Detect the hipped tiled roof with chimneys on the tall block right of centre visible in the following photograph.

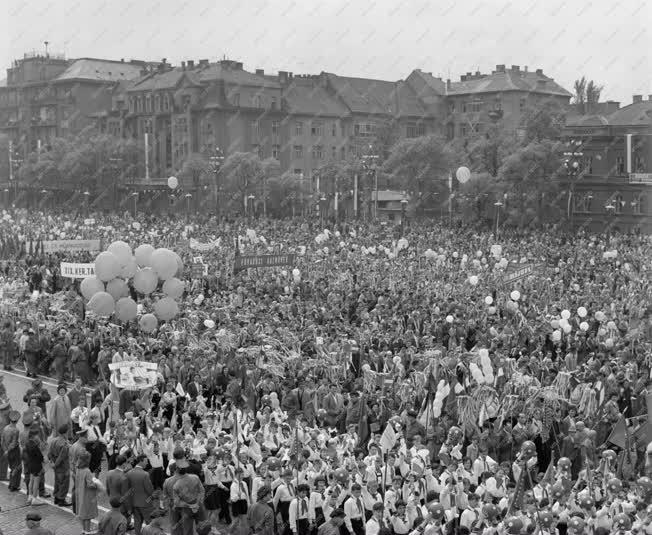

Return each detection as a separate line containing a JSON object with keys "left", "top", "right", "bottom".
{"left": 447, "top": 70, "right": 572, "bottom": 97}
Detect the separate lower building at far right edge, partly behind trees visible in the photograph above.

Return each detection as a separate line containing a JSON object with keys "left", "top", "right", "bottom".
{"left": 564, "top": 95, "right": 652, "bottom": 233}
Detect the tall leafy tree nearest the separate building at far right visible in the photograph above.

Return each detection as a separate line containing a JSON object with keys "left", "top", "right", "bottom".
{"left": 498, "top": 139, "right": 564, "bottom": 226}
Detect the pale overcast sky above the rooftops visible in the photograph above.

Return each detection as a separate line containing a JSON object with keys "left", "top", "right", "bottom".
{"left": 0, "top": 0, "right": 652, "bottom": 104}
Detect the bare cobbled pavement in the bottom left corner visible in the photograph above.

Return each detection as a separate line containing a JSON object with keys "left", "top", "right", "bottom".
{"left": 0, "top": 481, "right": 82, "bottom": 535}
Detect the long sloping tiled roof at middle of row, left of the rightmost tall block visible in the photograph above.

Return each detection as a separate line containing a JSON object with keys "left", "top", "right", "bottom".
{"left": 323, "top": 73, "right": 425, "bottom": 116}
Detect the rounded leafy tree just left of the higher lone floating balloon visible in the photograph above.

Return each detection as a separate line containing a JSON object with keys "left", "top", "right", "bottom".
{"left": 383, "top": 136, "right": 454, "bottom": 195}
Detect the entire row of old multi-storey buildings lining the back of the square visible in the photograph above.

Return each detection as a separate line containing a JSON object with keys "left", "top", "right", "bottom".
{"left": 0, "top": 53, "right": 652, "bottom": 232}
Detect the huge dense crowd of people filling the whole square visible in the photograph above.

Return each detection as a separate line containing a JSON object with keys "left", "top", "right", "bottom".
{"left": 0, "top": 206, "right": 652, "bottom": 535}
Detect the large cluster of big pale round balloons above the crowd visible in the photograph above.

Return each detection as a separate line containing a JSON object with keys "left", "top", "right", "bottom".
{"left": 81, "top": 241, "right": 185, "bottom": 332}
